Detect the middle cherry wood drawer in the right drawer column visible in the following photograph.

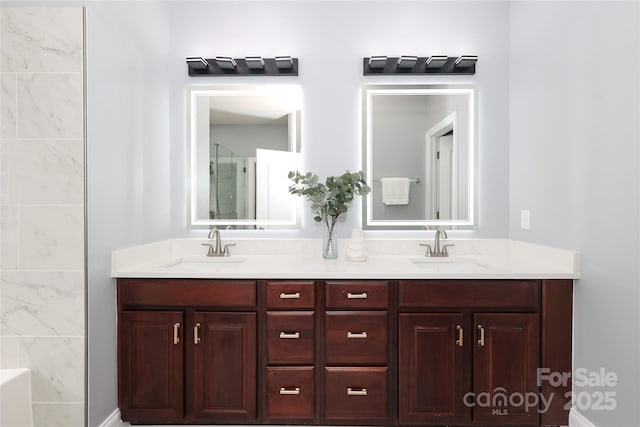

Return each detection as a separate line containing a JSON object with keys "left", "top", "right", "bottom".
{"left": 325, "top": 311, "right": 389, "bottom": 365}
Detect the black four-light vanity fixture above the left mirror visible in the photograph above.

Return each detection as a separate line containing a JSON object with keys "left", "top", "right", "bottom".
{"left": 186, "top": 56, "right": 298, "bottom": 76}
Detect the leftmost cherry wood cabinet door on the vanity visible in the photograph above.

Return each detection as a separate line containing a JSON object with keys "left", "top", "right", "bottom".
{"left": 118, "top": 311, "right": 184, "bottom": 423}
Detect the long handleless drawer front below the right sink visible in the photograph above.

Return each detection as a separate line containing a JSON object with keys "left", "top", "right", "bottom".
{"left": 399, "top": 280, "right": 540, "bottom": 311}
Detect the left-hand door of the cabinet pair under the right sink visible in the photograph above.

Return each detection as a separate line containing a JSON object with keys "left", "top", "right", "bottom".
{"left": 398, "top": 313, "right": 469, "bottom": 425}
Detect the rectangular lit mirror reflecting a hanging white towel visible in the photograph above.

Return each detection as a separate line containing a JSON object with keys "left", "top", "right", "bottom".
{"left": 363, "top": 85, "right": 476, "bottom": 229}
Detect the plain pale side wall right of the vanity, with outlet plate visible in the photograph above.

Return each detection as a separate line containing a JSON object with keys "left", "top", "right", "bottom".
{"left": 510, "top": 2, "right": 640, "bottom": 427}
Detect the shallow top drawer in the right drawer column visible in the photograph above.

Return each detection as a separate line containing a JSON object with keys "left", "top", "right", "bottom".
{"left": 325, "top": 281, "right": 389, "bottom": 309}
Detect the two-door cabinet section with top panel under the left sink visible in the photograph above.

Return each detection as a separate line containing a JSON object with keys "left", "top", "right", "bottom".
{"left": 118, "top": 279, "right": 257, "bottom": 424}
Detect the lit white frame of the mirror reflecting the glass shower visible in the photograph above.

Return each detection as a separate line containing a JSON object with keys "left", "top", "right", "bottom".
{"left": 186, "top": 84, "right": 302, "bottom": 230}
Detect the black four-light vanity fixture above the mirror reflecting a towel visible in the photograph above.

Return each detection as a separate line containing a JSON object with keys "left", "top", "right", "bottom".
{"left": 363, "top": 55, "right": 478, "bottom": 76}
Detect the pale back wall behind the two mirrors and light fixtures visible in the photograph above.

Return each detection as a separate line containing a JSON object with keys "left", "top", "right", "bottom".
{"left": 169, "top": 1, "right": 509, "bottom": 237}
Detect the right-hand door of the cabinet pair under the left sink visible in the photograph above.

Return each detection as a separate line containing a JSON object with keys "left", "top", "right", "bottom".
{"left": 193, "top": 312, "right": 257, "bottom": 423}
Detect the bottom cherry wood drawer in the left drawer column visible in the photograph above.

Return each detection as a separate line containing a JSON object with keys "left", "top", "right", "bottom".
{"left": 267, "top": 366, "right": 315, "bottom": 419}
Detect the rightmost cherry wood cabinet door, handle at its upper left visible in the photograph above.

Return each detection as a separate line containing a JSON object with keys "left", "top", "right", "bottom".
{"left": 473, "top": 314, "right": 540, "bottom": 425}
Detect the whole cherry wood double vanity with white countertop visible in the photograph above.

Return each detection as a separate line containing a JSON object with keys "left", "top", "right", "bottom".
{"left": 113, "top": 242, "right": 578, "bottom": 426}
